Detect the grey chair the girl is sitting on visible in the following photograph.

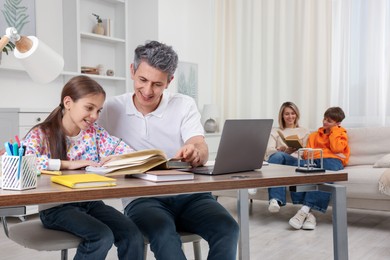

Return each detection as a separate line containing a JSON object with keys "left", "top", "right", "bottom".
{"left": 0, "top": 207, "right": 82, "bottom": 260}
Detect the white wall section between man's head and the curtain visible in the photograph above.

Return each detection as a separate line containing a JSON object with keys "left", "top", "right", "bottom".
{"left": 158, "top": 0, "right": 214, "bottom": 109}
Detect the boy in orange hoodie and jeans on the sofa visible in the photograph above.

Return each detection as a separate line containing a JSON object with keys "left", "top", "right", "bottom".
{"left": 289, "top": 107, "right": 350, "bottom": 230}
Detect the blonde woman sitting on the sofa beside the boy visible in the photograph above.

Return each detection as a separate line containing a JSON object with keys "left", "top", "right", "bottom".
{"left": 265, "top": 102, "right": 310, "bottom": 213}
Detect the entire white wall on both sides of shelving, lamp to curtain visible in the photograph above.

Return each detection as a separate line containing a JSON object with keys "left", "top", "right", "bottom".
{"left": 0, "top": 0, "right": 214, "bottom": 110}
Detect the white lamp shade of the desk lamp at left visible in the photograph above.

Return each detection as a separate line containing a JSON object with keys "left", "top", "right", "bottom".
{"left": 14, "top": 36, "right": 64, "bottom": 83}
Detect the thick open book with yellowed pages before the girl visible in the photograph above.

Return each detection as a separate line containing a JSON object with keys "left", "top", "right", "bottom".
{"left": 85, "top": 149, "right": 191, "bottom": 176}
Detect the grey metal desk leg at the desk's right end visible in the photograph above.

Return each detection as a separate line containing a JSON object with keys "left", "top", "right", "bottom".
{"left": 318, "top": 183, "right": 348, "bottom": 260}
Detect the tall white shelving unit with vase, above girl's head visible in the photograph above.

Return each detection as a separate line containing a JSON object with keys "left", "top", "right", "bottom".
{"left": 62, "top": 0, "right": 129, "bottom": 91}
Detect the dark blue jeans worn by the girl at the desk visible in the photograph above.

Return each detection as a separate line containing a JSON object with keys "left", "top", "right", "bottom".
{"left": 40, "top": 201, "right": 144, "bottom": 260}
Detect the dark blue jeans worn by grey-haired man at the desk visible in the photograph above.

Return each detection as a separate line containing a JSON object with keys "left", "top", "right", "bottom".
{"left": 125, "top": 193, "right": 239, "bottom": 260}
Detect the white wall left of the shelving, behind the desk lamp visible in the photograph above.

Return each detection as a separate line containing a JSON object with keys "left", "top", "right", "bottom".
{"left": 0, "top": 0, "right": 63, "bottom": 110}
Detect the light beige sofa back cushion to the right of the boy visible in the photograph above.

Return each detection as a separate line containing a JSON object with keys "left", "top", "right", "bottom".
{"left": 347, "top": 127, "right": 390, "bottom": 166}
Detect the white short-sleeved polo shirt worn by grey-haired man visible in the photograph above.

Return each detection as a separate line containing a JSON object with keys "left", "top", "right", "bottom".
{"left": 99, "top": 91, "right": 204, "bottom": 158}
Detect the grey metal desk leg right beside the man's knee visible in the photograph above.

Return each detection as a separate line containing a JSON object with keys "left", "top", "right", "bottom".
{"left": 237, "top": 189, "right": 250, "bottom": 260}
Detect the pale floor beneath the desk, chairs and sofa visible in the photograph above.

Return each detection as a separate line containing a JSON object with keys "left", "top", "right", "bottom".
{"left": 0, "top": 197, "right": 390, "bottom": 260}
